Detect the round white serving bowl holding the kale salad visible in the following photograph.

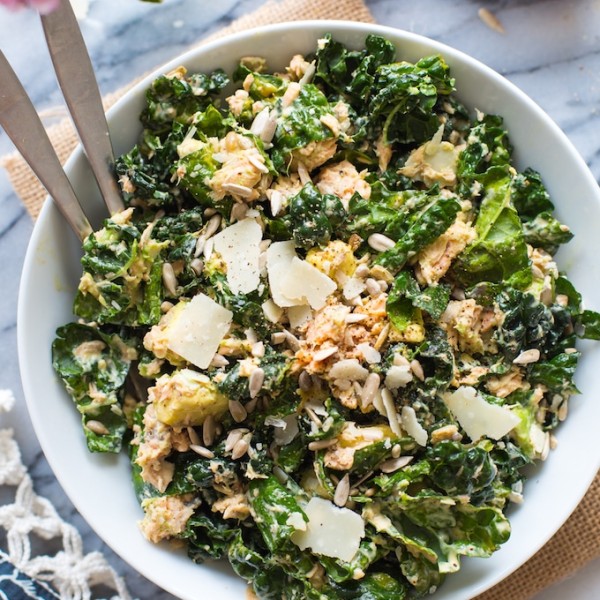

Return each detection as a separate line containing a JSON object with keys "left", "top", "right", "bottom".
{"left": 18, "top": 21, "right": 600, "bottom": 600}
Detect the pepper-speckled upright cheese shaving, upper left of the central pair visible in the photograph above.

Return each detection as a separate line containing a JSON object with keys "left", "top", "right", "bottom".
{"left": 213, "top": 219, "right": 262, "bottom": 294}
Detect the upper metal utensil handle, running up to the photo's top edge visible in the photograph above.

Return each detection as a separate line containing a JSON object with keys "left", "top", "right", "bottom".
{"left": 41, "top": 0, "right": 124, "bottom": 215}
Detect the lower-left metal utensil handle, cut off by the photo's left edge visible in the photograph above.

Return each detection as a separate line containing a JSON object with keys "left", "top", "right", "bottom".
{"left": 0, "top": 51, "right": 92, "bottom": 240}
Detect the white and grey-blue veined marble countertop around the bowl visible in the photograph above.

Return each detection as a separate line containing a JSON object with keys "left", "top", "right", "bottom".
{"left": 0, "top": 0, "right": 600, "bottom": 600}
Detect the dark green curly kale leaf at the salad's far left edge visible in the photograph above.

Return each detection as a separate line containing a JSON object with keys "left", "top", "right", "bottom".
{"left": 52, "top": 323, "right": 135, "bottom": 452}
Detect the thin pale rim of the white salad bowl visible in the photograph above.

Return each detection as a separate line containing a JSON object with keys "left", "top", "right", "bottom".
{"left": 17, "top": 19, "right": 600, "bottom": 597}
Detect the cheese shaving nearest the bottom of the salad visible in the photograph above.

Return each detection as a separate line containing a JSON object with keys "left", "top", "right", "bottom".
{"left": 291, "top": 497, "right": 365, "bottom": 562}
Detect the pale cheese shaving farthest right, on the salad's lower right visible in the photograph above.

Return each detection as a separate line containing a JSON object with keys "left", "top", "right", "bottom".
{"left": 444, "top": 386, "right": 519, "bottom": 441}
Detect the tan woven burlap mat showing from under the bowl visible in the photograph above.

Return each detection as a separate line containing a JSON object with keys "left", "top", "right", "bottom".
{"left": 1, "top": 0, "right": 600, "bottom": 600}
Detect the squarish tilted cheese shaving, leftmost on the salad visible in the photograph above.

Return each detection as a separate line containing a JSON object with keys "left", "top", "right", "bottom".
{"left": 167, "top": 294, "right": 233, "bottom": 369}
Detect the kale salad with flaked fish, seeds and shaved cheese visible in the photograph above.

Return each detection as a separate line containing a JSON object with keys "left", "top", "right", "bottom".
{"left": 52, "top": 35, "right": 600, "bottom": 600}
